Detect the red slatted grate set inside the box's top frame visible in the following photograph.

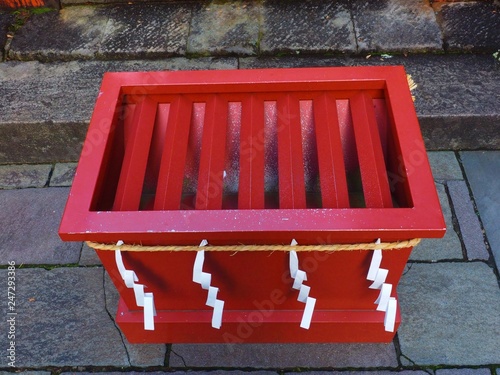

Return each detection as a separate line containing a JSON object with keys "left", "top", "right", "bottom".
{"left": 96, "top": 90, "right": 406, "bottom": 211}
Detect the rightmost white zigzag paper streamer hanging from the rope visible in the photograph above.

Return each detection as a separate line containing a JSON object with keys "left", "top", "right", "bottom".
{"left": 366, "top": 238, "right": 398, "bottom": 332}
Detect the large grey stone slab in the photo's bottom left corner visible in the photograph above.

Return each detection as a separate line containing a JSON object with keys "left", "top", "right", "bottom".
{"left": 0, "top": 268, "right": 130, "bottom": 368}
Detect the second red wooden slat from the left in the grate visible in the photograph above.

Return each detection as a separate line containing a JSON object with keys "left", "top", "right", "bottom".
{"left": 154, "top": 96, "right": 193, "bottom": 210}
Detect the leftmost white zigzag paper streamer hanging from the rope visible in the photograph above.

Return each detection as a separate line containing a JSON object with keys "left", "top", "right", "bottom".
{"left": 115, "top": 247, "right": 156, "bottom": 331}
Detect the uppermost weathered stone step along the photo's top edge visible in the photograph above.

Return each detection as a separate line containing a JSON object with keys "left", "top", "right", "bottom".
{"left": 0, "top": 0, "right": 500, "bottom": 61}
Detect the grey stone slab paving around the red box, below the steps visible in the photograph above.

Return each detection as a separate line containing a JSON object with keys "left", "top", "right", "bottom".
{"left": 0, "top": 151, "right": 500, "bottom": 375}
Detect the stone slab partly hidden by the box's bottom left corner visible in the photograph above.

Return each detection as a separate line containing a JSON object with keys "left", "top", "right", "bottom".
{"left": 104, "top": 272, "right": 167, "bottom": 367}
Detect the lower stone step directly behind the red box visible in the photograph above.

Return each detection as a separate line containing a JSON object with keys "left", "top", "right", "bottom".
{"left": 0, "top": 55, "right": 500, "bottom": 164}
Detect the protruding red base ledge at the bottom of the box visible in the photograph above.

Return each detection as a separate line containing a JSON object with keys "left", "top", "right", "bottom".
{"left": 116, "top": 301, "right": 401, "bottom": 344}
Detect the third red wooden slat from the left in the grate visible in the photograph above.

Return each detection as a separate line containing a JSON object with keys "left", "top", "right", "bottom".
{"left": 195, "top": 95, "right": 228, "bottom": 210}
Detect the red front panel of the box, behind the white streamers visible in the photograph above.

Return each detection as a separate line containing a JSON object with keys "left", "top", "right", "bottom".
{"left": 98, "top": 248, "right": 411, "bottom": 311}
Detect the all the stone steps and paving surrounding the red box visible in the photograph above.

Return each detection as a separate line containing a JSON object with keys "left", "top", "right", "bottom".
{"left": 0, "top": 0, "right": 500, "bottom": 375}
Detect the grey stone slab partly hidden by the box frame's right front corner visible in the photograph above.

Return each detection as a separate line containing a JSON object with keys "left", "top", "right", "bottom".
{"left": 410, "top": 183, "right": 464, "bottom": 261}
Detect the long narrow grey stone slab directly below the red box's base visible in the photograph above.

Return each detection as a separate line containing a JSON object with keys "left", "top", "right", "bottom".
{"left": 169, "top": 344, "right": 398, "bottom": 368}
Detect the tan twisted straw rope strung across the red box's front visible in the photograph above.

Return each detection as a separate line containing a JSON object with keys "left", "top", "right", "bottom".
{"left": 87, "top": 238, "right": 420, "bottom": 252}
